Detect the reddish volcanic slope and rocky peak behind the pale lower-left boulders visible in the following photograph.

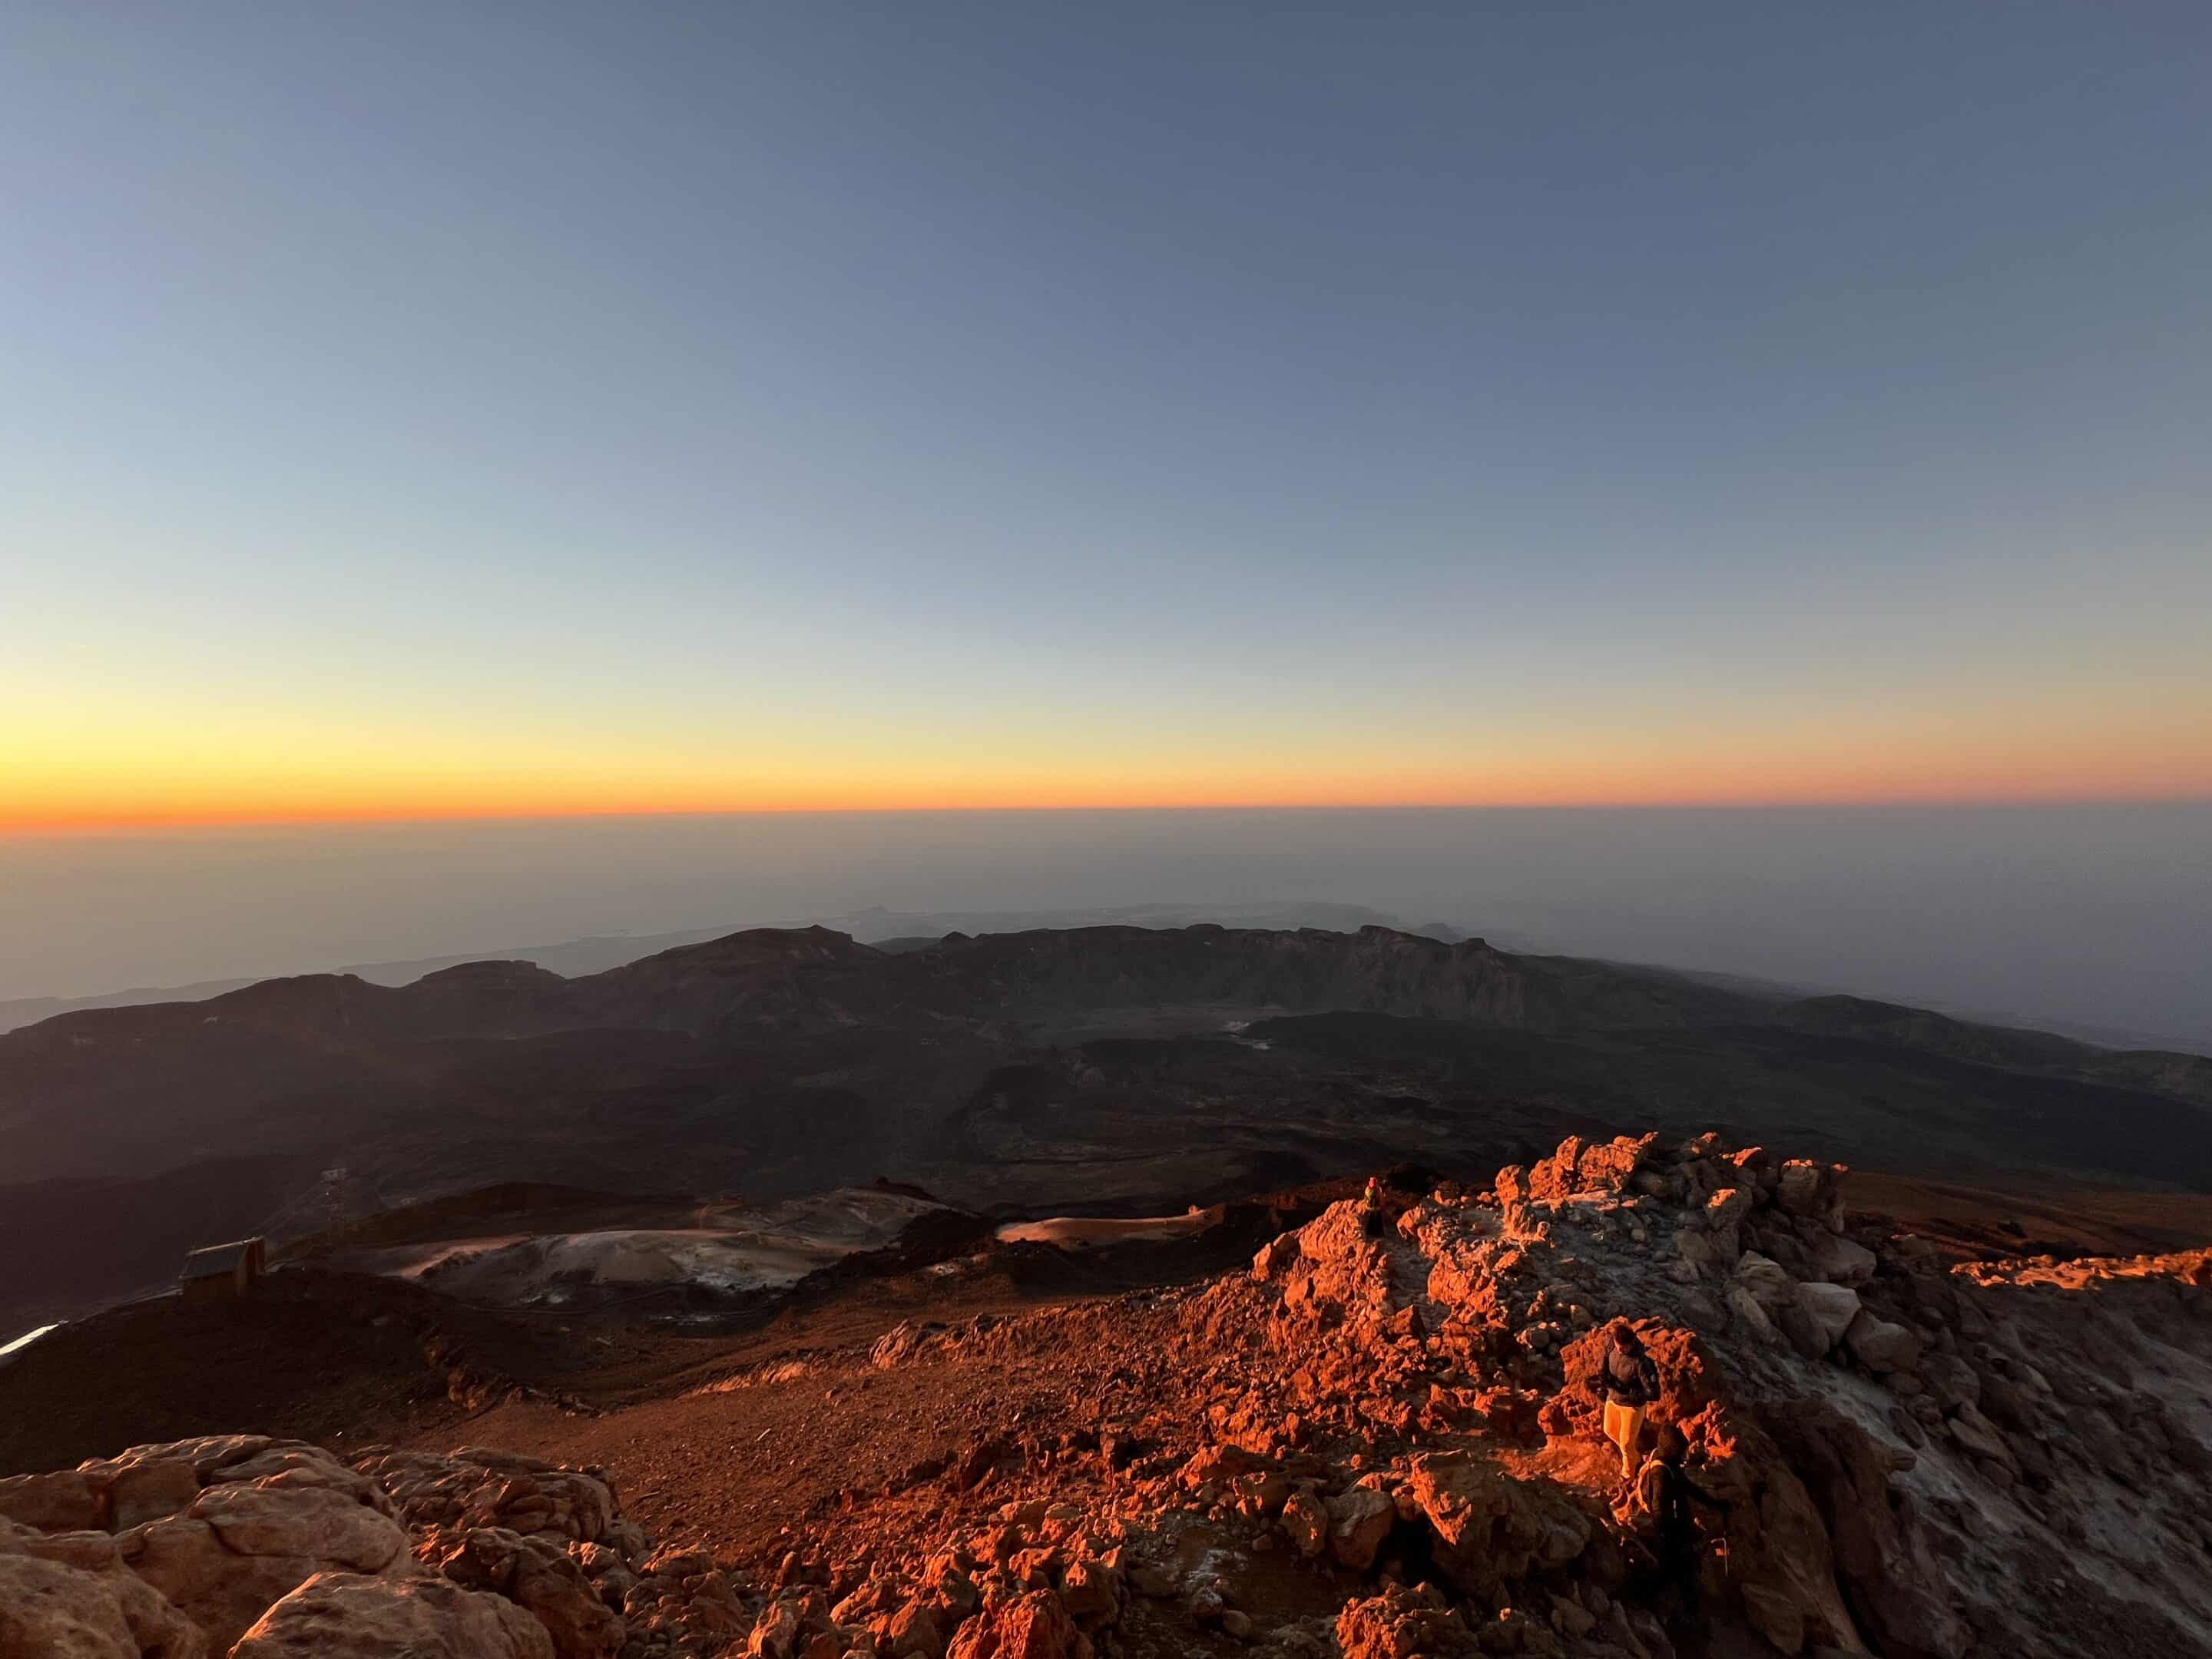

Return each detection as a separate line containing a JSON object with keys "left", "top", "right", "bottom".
{"left": 0, "top": 1134, "right": 2212, "bottom": 1659}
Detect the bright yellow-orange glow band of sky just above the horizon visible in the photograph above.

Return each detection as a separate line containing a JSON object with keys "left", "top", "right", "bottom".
{"left": 0, "top": 699, "right": 2212, "bottom": 836}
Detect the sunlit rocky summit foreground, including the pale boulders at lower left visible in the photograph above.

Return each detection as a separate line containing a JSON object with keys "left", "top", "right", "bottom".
{"left": 0, "top": 1134, "right": 2212, "bottom": 1659}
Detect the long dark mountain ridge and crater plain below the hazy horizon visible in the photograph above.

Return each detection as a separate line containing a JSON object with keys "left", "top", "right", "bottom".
{"left": 0, "top": 925, "right": 2212, "bottom": 1316}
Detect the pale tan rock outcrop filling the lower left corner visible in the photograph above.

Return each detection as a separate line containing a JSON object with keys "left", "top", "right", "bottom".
{"left": 0, "top": 1435, "right": 765, "bottom": 1659}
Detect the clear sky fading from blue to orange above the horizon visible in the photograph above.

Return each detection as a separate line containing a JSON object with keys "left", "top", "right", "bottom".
{"left": 0, "top": 0, "right": 2212, "bottom": 834}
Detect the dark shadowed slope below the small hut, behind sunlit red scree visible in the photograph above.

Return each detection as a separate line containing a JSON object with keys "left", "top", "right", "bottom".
{"left": 0, "top": 1234, "right": 1250, "bottom": 1473}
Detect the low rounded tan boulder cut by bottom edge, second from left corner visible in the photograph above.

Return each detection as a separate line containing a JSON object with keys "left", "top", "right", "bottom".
{"left": 230, "top": 1573, "right": 553, "bottom": 1659}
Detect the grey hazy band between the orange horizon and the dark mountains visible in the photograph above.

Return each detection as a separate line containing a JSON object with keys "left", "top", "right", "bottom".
{"left": 0, "top": 801, "right": 2212, "bottom": 1041}
